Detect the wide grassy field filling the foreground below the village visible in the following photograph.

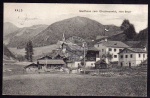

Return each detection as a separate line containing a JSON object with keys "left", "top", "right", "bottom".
{"left": 3, "top": 74, "right": 147, "bottom": 96}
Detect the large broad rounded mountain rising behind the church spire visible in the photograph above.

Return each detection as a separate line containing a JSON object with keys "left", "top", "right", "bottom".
{"left": 32, "top": 16, "right": 121, "bottom": 47}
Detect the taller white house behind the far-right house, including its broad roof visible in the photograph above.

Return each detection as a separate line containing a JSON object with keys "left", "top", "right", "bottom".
{"left": 94, "top": 39, "right": 129, "bottom": 62}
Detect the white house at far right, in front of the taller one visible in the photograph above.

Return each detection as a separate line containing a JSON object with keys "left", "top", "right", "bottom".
{"left": 118, "top": 48, "right": 147, "bottom": 67}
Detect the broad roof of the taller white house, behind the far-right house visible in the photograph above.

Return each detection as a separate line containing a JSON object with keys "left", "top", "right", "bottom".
{"left": 98, "top": 41, "right": 129, "bottom": 48}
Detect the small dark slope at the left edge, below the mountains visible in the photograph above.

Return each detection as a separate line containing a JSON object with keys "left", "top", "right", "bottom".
{"left": 3, "top": 44, "right": 16, "bottom": 60}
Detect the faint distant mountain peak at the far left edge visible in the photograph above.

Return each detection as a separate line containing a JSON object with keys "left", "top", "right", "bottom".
{"left": 3, "top": 22, "right": 19, "bottom": 36}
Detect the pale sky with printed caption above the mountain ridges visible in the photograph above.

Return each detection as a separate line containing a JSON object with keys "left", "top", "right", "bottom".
{"left": 4, "top": 3, "right": 148, "bottom": 33}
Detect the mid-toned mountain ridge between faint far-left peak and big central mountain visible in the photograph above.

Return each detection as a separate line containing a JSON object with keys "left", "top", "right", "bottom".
{"left": 4, "top": 25, "right": 47, "bottom": 48}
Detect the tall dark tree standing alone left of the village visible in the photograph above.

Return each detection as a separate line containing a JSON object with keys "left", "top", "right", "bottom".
{"left": 25, "top": 40, "right": 33, "bottom": 62}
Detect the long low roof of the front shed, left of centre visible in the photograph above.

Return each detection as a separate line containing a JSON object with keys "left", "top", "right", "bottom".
{"left": 39, "top": 59, "right": 65, "bottom": 65}
